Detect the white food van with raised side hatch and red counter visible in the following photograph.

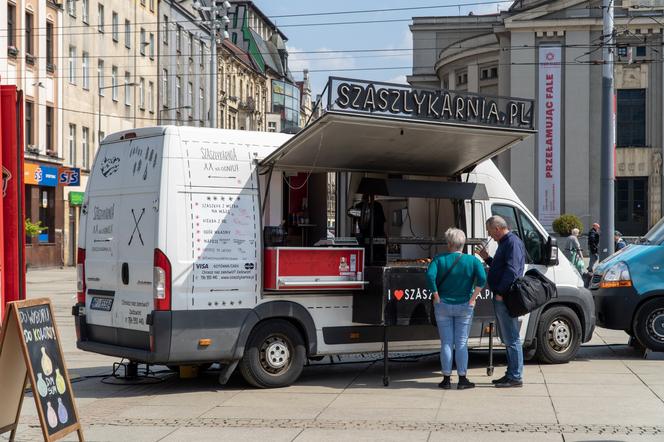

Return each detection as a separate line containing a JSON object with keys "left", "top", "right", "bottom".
{"left": 73, "top": 78, "right": 595, "bottom": 387}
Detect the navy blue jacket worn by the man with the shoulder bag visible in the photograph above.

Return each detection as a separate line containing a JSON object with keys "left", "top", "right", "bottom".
{"left": 485, "top": 232, "right": 526, "bottom": 295}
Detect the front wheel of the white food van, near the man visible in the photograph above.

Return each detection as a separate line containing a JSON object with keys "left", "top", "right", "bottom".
{"left": 536, "top": 305, "right": 582, "bottom": 364}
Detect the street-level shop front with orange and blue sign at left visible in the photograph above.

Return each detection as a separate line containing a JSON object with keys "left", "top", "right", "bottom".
{"left": 24, "top": 160, "right": 63, "bottom": 267}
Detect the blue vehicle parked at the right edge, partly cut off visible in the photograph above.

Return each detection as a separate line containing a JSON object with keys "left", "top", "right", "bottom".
{"left": 590, "top": 218, "right": 664, "bottom": 351}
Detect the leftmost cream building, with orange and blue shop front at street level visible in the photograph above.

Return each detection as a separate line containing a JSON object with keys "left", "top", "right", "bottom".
{"left": 0, "top": 0, "right": 66, "bottom": 266}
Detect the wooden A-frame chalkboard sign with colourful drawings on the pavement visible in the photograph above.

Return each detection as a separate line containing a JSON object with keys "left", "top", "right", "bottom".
{"left": 0, "top": 298, "right": 84, "bottom": 442}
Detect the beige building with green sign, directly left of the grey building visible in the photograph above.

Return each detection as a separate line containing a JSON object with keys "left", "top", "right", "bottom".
{"left": 58, "top": 0, "right": 158, "bottom": 265}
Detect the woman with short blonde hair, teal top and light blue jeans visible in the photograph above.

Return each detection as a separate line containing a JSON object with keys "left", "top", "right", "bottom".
{"left": 427, "top": 228, "right": 486, "bottom": 390}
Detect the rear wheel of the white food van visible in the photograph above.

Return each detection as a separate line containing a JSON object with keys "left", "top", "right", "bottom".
{"left": 240, "top": 319, "right": 307, "bottom": 388}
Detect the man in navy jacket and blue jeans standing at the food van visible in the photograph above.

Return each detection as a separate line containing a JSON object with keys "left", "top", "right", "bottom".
{"left": 478, "top": 216, "right": 526, "bottom": 388}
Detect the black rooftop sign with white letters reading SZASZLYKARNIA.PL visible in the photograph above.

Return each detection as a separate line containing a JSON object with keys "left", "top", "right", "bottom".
{"left": 327, "top": 77, "right": 534, "bottom": 130}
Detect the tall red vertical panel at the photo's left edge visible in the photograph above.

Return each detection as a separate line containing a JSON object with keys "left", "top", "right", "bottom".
{"left": 0, "top": 86, "right": 25, "bottom": 318}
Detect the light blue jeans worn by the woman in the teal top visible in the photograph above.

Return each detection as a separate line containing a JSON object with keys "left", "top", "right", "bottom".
{"left": 433, "top": 301, "right": 473, "bottom": 376}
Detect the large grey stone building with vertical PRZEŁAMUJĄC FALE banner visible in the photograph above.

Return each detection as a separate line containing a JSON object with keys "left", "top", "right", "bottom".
{"left": 408, "top": 0, "right": 664, "bottom": 236}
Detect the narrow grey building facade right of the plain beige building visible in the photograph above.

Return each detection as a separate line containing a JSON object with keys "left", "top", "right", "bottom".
{"left": 156, "top": 0, "right": 212, "bottom": 127}
